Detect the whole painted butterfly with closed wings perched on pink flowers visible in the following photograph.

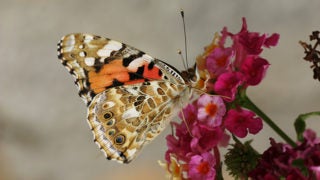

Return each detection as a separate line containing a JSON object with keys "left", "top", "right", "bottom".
{"left": 58, "top": 33, "right": 203, "bottom": 163}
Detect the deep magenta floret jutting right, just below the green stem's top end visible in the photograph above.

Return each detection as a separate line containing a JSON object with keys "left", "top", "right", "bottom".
{"left": 224, "top": 108, "right": 262, "bottom": 138}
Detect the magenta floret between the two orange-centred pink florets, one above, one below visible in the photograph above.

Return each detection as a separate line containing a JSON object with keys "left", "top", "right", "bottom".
{"left": 190, "top": 125, "right": 223, "bottom": 153}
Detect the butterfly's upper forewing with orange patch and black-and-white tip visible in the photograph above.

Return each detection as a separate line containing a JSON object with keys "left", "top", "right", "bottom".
{"left": 58, "top": 33, "right": 184, "bottom": 105}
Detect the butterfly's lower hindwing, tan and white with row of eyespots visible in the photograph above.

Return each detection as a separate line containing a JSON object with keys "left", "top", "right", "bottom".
{"left": 88, "top": 81, "right": 185, "bottom": 163}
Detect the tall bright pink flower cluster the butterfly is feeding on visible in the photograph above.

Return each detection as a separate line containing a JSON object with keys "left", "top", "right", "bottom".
{"left": 161, "top": 18, "right": 279, "bottom": 179}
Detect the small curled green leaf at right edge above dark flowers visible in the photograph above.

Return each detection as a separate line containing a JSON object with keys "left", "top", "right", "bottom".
{"left": 294, "top": 111, "right": 320, "bottom": 142}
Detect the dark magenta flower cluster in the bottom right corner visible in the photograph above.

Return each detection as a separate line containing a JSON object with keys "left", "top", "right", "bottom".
{"left": 249, "top": 129, "right": 320, "bottom": 180}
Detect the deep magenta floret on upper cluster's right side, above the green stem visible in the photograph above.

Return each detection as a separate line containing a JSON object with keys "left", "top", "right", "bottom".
{"left": 241, "top": 56, "right": 270, "bottom": 86}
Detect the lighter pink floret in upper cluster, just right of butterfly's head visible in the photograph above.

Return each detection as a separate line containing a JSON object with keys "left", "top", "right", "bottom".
{"left": 206, "top": 47, "right": 233, "bottom": 77}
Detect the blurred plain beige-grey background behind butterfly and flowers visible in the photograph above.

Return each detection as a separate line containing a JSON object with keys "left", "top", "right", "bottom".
{"left": 0, "top": 0, "right": 320, "bottom": 180}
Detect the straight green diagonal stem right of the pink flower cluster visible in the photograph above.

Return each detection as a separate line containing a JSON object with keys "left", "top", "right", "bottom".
{"left": 241, "top": 93, "right": 297, "bottom": 147}
